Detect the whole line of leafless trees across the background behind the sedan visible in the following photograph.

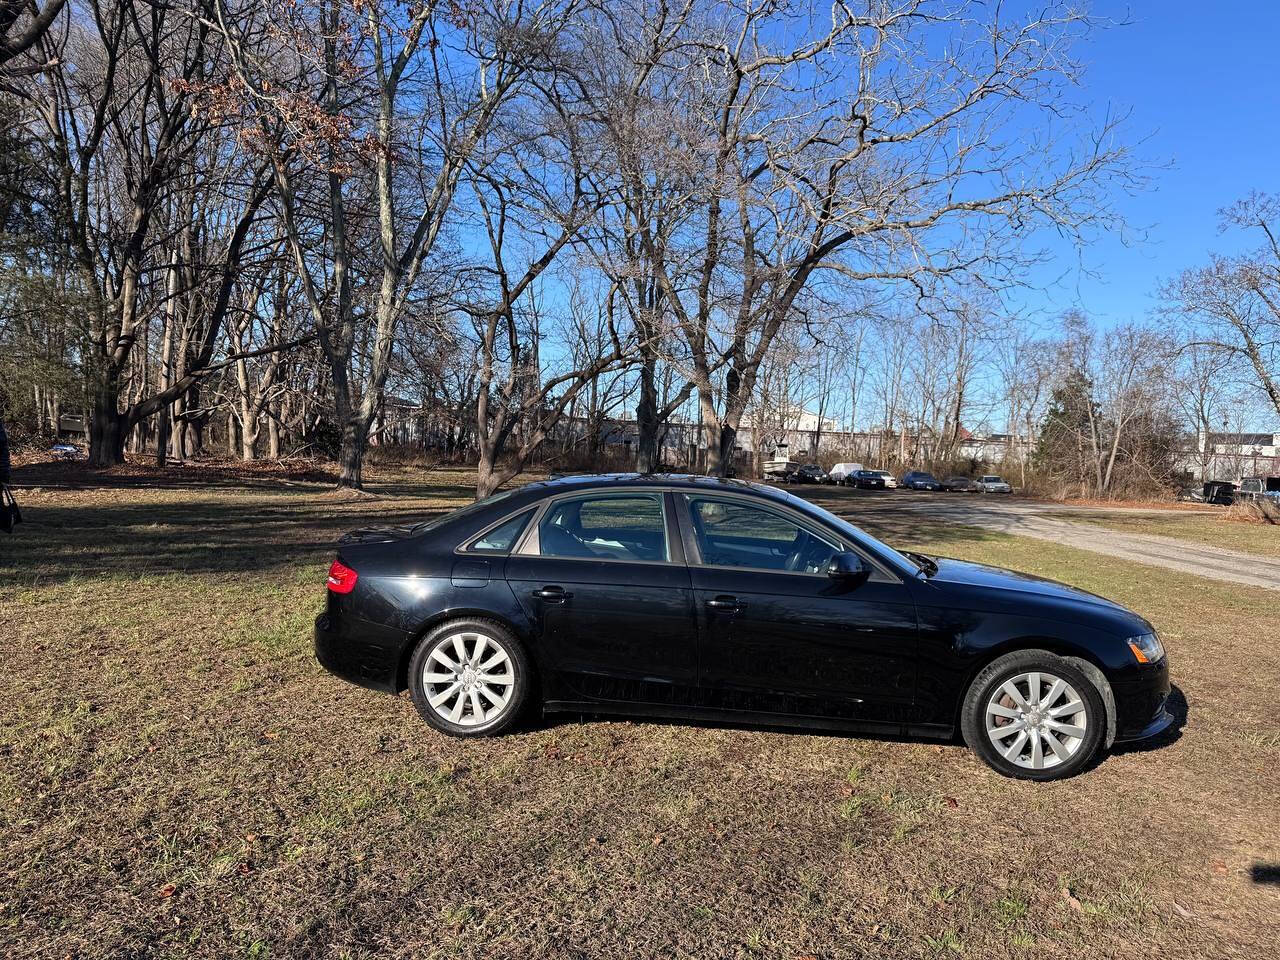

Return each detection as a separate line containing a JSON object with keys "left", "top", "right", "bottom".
{"left": 0, "top": 0, "right": 1280, "bottom": 495}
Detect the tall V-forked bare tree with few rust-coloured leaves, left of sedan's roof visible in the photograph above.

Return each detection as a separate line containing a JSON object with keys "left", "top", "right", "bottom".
{"left": 212, "top": 0, "right": 576, "bottom": 488}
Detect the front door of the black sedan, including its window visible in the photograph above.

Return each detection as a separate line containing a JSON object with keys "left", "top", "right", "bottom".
{"left": 675, "top": 493, "right": 916, "bottom": 722}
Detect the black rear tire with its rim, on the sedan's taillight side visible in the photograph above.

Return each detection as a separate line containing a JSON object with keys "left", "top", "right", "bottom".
{"left": 408, "top": 617, "right": 535, "bottom": 737}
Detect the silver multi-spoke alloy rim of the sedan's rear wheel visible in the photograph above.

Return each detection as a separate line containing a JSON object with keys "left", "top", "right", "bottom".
{"left": 422, "top": 631, "right": 516, "bottom": 727}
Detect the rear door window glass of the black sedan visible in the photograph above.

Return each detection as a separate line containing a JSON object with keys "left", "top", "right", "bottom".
{"left": 538, "top": 494, "right": 671, "bottom": 563}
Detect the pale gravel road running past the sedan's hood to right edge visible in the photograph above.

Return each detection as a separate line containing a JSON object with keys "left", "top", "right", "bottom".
{"left": 814, "top": 492, "right": 1280, "bottom": 590}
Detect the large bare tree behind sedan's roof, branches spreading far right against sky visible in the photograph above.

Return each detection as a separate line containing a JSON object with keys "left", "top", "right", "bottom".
{"left": 629, "top": 1, "right": 1129, "bottom": 472}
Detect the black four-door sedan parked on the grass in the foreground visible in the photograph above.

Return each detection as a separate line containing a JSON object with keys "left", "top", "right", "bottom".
{"left": 315, "top": 476, "right": 1172, "bottom": 780}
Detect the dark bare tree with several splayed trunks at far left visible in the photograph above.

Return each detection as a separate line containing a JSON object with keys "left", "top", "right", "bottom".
{"left": 27, "top": 0, "right": 280, "bottom": 466}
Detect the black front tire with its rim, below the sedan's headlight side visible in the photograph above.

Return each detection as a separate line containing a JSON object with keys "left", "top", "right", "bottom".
{"left": 960, "top": 650, "right": 1107, "bottom": 781}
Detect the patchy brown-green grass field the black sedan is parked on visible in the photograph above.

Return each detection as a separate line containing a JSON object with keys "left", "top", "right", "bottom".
{"left": 0, "top": 472, "right": 1280, "bottom": 960}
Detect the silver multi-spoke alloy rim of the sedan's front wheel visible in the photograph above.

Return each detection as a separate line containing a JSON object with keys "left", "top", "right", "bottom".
{"left": 986, "top": 671, "right": 1089, "bottom": 771}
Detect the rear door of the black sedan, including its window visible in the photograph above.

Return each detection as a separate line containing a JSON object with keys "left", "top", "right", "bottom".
{"left": 506, "top": 490, "right": 698, "bottom": 705}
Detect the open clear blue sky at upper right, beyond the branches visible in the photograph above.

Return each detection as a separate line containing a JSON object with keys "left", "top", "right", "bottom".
{"left": 1018, "top": 0, "right": 1280, "bottom": 323}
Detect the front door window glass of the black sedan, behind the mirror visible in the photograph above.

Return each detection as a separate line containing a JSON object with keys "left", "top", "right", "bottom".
{"left": 687, "top": 497, "right": 842, "bottom": 573}
